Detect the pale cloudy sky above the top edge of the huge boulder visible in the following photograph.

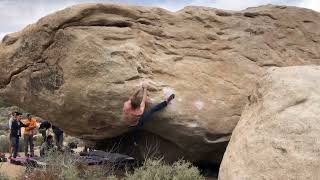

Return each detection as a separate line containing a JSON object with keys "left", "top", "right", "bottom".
{"left": 0, "top": 0, "right": 320, "bottom": 39}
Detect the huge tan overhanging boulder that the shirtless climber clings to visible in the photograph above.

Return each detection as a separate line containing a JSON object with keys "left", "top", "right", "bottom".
{"left": 0, "top": 4, "right": 320, "bottom": 162}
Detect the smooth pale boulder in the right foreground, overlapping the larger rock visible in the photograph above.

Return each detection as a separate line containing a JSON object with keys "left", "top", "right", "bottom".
{"left": 219, "top": 66, "right": 320, "bottom": 180}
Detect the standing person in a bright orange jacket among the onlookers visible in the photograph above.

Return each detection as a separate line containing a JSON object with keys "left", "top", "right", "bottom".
{"left": 23, "top": 114, "right": 37, "bottom": 157}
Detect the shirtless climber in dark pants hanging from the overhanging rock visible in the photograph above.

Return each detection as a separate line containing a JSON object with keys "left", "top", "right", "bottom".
{"left": 122, "top": 85, "right": 175, "bottom": 145}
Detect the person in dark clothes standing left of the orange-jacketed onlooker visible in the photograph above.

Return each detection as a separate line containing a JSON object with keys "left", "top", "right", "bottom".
{"left": 10, "top": 112, "right": 28, "bottom": 158}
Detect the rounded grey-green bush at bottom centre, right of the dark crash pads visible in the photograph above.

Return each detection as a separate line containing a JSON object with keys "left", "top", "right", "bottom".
{"left": 125, "top": 159, "right": 205, "bottom": 180}
